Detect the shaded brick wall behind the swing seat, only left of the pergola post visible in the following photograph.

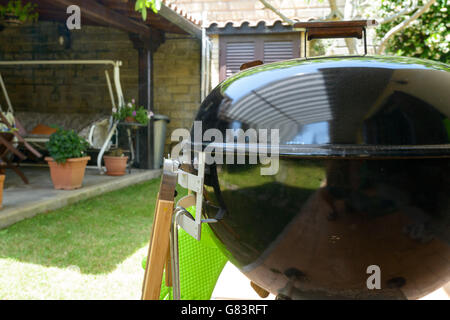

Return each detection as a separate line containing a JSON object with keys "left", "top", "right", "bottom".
{"left": 0, "top": 22, "right": 138, "bottom": 117}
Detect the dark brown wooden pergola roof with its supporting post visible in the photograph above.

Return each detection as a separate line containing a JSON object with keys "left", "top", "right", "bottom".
{"left": 0, "top": 0, "right": 202, "bottom": 168}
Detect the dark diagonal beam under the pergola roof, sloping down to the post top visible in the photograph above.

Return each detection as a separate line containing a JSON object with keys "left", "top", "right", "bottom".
{"left": 45, "top": 0, "right": 159, "bottom": 39}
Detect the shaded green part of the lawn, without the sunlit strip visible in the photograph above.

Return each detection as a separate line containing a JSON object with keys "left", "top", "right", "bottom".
{"left": 0, "top": 179, "right": 185, "bottom": 274}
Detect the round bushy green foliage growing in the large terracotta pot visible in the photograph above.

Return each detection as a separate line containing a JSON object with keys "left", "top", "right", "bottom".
{"left": 46, "top": 128, "right": 89, "bottom": 163}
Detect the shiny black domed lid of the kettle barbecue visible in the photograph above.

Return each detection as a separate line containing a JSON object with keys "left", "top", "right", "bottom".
{"left": 195, "top": 56, "right": 450, "bottom": 156}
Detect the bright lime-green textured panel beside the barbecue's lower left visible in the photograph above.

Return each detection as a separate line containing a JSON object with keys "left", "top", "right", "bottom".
{"left": 142, "top": 206, "right": 228, "bottom": 300}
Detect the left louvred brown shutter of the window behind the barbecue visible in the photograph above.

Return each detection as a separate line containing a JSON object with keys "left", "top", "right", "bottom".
{"left": 226, "top": 42, "right": 255, "bottom": 78}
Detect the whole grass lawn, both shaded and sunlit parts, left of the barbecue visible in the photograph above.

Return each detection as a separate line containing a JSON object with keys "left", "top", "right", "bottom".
{"left": 0, "top": 179, "right": 184, "bottom": 299}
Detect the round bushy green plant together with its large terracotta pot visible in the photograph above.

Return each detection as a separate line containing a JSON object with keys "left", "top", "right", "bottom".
{"left": 45, "top": 128, "right": 91, "bottom": 190}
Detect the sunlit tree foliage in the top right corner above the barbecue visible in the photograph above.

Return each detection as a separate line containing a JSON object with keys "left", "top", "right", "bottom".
{"left": 377, "top": 0, "right": 450, "bottom": 63}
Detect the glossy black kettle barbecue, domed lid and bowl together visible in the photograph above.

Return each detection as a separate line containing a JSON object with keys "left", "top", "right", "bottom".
{"left": 192, "top": 56, "right": 450, "bottom": 299}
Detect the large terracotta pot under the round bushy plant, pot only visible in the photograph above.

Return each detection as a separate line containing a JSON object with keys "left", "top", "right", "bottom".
{"left": 45, "top": 157, "right": 91, "bottom": 190}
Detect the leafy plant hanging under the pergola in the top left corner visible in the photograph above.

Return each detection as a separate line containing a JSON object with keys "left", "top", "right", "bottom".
{"left": 0, "top": 0, "right": 39, "bottom": 26}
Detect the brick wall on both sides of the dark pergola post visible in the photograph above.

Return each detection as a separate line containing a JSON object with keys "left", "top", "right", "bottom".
{"left": 0, "top": 22, "right": 201, "bottom": 154}
